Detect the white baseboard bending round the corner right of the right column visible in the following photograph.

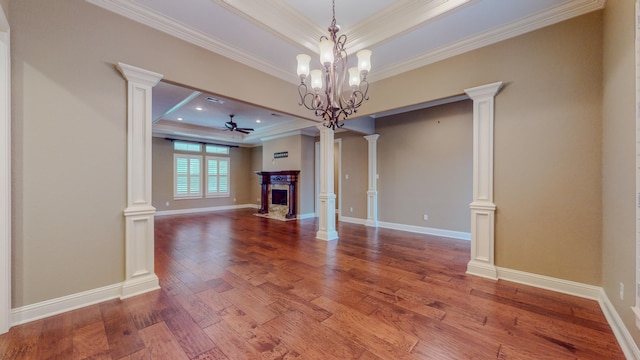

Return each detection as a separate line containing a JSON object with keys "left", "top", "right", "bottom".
{"left": 497, "top": 267, "right": 640, "bottom": 360}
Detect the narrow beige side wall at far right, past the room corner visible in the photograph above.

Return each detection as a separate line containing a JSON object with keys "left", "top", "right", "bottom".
{"left": 602, "top": 0, "right": 640, "bottom": 342}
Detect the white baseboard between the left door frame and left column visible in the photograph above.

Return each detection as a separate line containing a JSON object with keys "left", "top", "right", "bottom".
{"left": 11, "top": 283, "right": 122, "bottom": 326}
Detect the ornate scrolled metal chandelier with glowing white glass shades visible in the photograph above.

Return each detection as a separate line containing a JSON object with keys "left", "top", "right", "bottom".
{"left": 296, "top": 0, "right": 371, "bottom": 130}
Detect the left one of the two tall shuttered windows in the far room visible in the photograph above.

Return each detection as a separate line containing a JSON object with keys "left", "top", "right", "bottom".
{"left": 173, "top": 154, "right": 202, "bottom": 199}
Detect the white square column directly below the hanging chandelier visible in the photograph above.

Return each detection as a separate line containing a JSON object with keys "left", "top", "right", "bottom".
{"left": 316, "top": 124, "right": 338, "bottom": 241}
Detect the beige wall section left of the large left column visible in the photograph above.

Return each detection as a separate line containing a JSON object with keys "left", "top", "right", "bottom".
{"left": 10, "top": 1, "right": 127, "bottom": 307}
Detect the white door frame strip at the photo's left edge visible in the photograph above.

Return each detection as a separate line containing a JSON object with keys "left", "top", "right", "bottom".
{"left": 0, "top": 2, "right": 11, "bottom": 334}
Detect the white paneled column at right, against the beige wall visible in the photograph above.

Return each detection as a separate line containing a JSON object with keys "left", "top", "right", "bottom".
{"left": 465, "top": 82, "right": 502, "bottom": 279}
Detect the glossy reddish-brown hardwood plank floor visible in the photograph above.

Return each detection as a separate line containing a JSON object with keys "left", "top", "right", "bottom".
{"left": 0, "top": 210, "right": 624, "bottom": 360}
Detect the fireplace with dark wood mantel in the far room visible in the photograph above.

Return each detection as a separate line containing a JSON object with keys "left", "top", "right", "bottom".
{"left": 256, "top": 170, "right": 300, "bottom": 219}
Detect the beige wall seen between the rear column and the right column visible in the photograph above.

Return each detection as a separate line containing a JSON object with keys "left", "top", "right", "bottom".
{"left": 376, "top": 100, "right": 473, "bottom": 232}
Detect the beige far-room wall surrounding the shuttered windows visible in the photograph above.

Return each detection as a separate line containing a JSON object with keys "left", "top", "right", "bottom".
{"left": 152, "top": 138, "right": 258, "bottom": 211}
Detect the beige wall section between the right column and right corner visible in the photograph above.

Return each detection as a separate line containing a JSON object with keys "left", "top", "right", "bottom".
{"left": 488, "top": 12, "right": 602, "bottom": 285}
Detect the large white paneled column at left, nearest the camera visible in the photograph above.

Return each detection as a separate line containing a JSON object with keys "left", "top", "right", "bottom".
{"left": 117, "top": 63, "right": 162, "bottom": 299}
